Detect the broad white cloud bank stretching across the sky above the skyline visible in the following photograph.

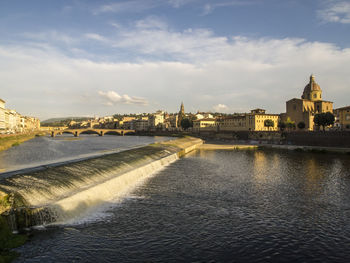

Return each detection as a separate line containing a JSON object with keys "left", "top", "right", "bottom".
{"left": 0, "top": 24, "right": 350, "bottom": 120}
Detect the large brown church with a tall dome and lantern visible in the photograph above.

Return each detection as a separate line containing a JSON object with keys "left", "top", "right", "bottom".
{"left": 285, "top": 75, "right": 333, "bottom": 130}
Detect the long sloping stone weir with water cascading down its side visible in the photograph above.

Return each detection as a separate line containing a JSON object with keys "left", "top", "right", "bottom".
{"left": 0, "top": 137, "right": 202, "bottom": 231}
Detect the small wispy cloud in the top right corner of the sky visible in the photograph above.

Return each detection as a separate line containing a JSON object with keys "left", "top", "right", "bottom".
{"left": 317, "top": 1, "right": 350, "bottom": 24}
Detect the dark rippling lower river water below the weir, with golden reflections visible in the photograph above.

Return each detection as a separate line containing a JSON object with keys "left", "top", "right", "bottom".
{"left": 18, "top": 151, "right": 350, "bottom": 262}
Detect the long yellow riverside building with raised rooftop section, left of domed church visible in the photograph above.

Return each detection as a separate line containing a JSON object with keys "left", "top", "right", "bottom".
{"left": 219, "top": 109, "right": 279, "bottom": 131}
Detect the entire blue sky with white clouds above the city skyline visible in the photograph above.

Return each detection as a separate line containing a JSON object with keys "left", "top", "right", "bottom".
{"left": 0, "top": 0, "right": 350, "bottom": 120}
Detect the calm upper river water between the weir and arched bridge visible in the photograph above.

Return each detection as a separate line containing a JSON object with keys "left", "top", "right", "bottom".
{"left": 0, "top": 134, "right": 169, "bottom": 173}
